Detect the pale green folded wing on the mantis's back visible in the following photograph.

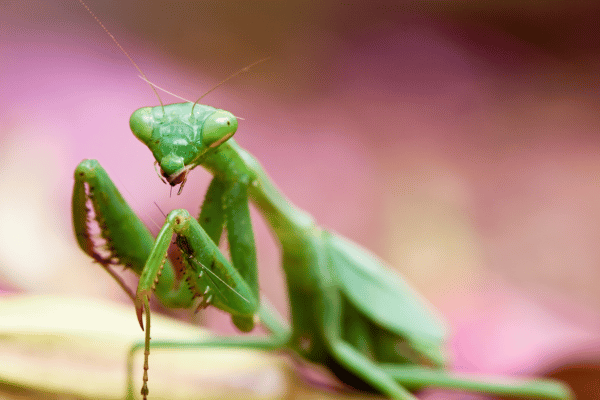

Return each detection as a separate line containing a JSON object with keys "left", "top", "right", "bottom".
{"left": 329, "top": 234, "right": 447, "bottom": 346}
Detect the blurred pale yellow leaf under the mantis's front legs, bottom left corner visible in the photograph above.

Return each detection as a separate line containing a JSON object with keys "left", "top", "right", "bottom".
{"left": 0, "top": 295, "right": 384, "bottom": 400}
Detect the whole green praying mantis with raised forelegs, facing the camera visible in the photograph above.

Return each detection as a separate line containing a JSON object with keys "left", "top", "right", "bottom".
{"left": 72, "top": 1, "right": 572, "bottom": 400}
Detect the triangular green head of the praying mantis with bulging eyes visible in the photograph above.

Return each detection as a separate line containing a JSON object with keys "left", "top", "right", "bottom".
{"left": 129, "top": 103, "right": 237, "bottom": 191}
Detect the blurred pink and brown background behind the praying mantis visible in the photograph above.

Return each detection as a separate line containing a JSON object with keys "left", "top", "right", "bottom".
{"left": 0, "top": 0, "right": 600, "bottom": 398}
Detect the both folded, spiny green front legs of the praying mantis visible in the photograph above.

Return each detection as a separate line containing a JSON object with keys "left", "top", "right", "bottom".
{"left": 73, "top": 160, "right": 258, "bottom": 397}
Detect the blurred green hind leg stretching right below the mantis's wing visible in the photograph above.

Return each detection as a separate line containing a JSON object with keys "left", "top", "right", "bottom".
{"left": 320, "top": 289, "right": 574, "bottom": 400}
